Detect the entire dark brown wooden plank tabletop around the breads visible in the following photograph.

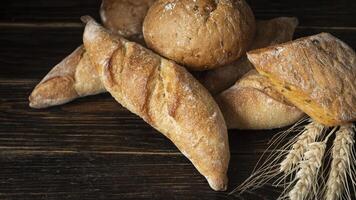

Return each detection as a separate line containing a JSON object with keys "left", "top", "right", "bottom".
{"left": 0, "top": 0, "right": 356, "bottom": 200}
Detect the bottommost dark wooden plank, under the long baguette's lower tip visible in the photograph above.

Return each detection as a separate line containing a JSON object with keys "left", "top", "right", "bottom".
{"left": 0, "top": 151, "right": 278, "bottom": 200}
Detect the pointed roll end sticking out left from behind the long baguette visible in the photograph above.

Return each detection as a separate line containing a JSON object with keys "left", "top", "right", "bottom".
{"left": 29, "top": 46, "right": 105, "bottom": 108}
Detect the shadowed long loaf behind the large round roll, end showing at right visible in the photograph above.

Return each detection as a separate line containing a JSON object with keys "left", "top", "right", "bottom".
{"left": 198, "top": 17, "right": 298, "bottom": 95}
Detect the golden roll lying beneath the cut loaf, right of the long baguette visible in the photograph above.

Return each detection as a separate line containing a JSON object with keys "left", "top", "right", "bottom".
{"left": 216, "top": 69, "right": 304, "bottom": 129}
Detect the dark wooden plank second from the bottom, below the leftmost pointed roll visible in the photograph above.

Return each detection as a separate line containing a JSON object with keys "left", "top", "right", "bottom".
{"left": 0, "top": 79, "right": 276, "bottom": 154}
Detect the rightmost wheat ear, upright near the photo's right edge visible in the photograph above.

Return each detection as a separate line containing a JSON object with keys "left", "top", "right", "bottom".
{"left": 325, "top": 125, "right": 355, "bottom": 200}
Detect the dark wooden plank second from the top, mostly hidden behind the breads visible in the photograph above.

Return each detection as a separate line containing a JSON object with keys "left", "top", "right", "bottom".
{"left": 0, "top": 27, "right": 356, "bottom": 80}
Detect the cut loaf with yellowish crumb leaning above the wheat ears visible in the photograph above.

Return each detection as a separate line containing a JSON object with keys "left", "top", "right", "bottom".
{"left": 247, "top": 33, "right": 356, "bottom": 126}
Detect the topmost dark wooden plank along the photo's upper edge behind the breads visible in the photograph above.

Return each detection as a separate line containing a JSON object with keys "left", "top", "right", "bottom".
{"left": 0, "top": 0, "right": 356, "bottom": 27}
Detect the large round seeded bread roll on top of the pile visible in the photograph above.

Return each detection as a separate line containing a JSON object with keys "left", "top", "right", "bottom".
{"left": 143, "top": 0, "right": 256, "bottom": 71}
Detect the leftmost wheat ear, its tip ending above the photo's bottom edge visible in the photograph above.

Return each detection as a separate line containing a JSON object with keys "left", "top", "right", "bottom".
{"left": 280, "top": 122, "right": 324, "bottom": 174}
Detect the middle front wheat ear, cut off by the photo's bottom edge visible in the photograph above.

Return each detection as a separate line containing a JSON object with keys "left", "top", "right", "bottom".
{"left": 289, "top": 141, "right": 326, "bottom": 200}
